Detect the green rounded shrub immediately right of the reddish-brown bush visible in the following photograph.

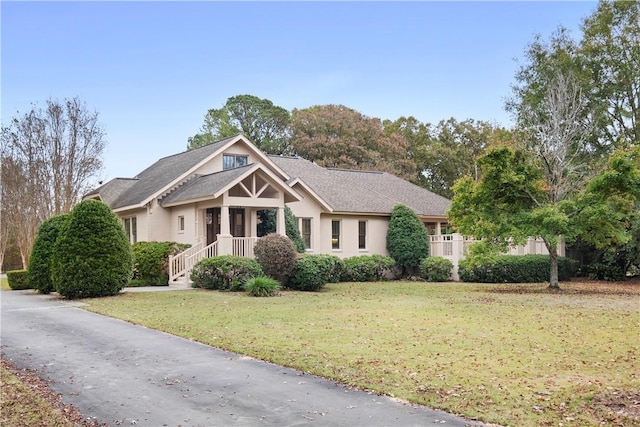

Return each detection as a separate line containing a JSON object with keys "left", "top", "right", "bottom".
{"left": 288, "top": 254, "right": 344, "bottom": 291}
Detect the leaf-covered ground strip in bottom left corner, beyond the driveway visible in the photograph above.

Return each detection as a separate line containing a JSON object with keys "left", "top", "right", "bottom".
{"left": 0, "top": 359, "right": 106, "bottom": 427}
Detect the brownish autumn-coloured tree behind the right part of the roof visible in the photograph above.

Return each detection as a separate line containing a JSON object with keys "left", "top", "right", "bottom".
{"left": 291, "top": 105, "right": 416, "bottom": 179}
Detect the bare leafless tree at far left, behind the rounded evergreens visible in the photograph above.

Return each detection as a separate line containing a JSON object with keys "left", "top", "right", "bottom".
{"left": 0, "top": 98, "right": 105, "bottom": 266}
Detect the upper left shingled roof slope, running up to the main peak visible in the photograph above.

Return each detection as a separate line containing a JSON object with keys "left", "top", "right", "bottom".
{"left": 99, "top": 135, "right": 237, "bottom": 209}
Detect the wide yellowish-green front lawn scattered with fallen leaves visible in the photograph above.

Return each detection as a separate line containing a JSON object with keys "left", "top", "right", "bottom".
{"left": 86, "top": 282, "right": 640, "bottom": 426}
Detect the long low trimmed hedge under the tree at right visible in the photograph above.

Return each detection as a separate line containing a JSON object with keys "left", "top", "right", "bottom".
{"left": 458, "top": 255, "right": 577, "bottom": 283}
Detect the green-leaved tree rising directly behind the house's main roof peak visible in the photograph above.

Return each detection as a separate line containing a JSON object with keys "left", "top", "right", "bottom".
{"left": 187, "top": 95, "right": 291, "bottom": 154}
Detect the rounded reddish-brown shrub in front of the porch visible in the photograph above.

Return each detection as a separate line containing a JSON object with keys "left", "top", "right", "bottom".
{"left": 254, "top": 233, "right": 298, "bottom": 284}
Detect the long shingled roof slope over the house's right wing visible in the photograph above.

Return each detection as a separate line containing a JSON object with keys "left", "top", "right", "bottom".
{"left": 270, "top": 156, "right": 451, "bottom": 217}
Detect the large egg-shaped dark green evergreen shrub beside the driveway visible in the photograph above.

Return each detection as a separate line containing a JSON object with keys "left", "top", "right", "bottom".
{"left": 52, "top": 200, "right": 133, "bottom": 298}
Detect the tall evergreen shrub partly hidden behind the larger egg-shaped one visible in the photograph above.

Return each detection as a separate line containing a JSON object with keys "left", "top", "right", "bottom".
{"left": 27, "top": 214, "right": 71, "bottom": 294}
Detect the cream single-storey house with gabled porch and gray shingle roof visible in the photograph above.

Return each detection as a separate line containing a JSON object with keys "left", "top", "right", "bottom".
{"left": 85, "top": 134, "right": 450, "bottom": 280}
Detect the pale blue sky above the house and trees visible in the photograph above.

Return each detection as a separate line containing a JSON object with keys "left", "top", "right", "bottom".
{"left": 0, "top": 1, "right": 597, "bottom": 180}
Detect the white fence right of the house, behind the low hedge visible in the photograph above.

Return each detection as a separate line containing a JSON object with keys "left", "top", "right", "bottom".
{"left": 429, "top": 233, "right": 564, "bottom": 280}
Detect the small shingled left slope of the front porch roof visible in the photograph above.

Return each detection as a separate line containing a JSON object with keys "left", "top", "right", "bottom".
{"left": 160, "top": 164, "right": 254, "bottom": 205}
